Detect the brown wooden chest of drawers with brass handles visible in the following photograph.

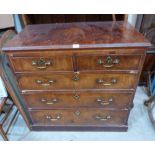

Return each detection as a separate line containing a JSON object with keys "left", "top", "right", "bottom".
{"left": 3, "top": 22, "right": 150, "bottom": 131}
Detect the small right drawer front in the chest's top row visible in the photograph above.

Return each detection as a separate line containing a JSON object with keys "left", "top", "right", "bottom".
{"left": 77, "top": 55, "right": 141, "bottom": 71}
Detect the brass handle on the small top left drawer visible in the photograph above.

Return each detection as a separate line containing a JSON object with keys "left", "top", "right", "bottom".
{"left": 32, "top": 59, "right": 52, "bottom": 69}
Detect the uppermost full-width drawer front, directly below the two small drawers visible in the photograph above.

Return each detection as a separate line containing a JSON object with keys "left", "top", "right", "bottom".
{"left": 18, "top": 73, "right": 137, "bottom": 90}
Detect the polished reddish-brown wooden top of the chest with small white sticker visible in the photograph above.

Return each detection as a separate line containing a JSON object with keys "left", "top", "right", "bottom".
{"left": 3, "top": 21, "right": 150, "bottom": 51}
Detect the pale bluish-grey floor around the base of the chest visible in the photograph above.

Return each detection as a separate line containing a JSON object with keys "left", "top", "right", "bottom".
{"left": 0, "top": 87, "right": 155, "bottom": 141}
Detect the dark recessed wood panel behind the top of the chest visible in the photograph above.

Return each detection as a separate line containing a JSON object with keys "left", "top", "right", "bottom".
{"left": 26, "top": 14, "right": 125, "bottom": 24}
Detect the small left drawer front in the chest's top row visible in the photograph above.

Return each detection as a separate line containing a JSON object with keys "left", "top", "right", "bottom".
{"left": 11, "top": 56, "right": 73, "bottom": 72}
